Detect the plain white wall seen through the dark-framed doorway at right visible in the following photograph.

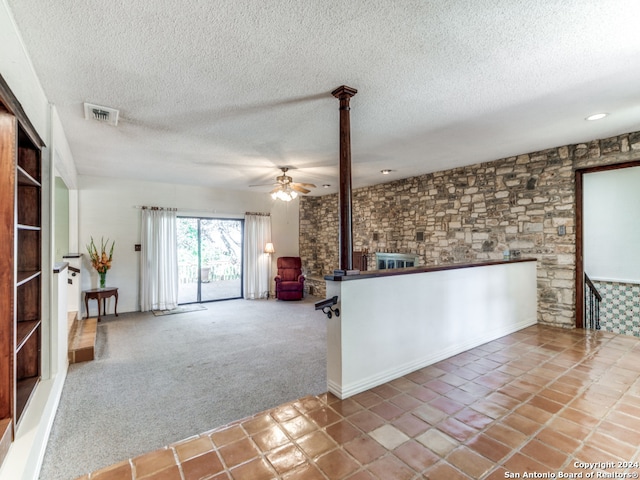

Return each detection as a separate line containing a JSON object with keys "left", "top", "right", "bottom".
{"left": 583, "top": 167, "right": 640, "bottom": 283}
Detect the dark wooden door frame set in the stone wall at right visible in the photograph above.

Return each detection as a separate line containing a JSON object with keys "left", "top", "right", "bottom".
{"left": 575, "top": 160, "right": 640, "bottom": 328}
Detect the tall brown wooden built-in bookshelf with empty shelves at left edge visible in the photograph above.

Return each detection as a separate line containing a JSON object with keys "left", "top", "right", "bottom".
{"left": 0, "top": 77, "right": 42, "bottom": 462}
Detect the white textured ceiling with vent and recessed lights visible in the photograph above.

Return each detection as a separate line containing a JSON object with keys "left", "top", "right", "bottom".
{"left": 7, "top": 0, "right": 640, "bottom": 194}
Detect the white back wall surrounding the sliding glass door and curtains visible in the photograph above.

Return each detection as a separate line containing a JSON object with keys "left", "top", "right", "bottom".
{"left": 78, "top": 175, "right": 298, "bottom": 313}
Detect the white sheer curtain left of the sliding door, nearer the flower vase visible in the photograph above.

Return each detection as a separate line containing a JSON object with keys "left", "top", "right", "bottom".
{"left": 140, "top": 208, "right": 178, "bottom": 312}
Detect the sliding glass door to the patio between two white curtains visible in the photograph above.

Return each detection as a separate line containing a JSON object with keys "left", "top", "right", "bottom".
{"left": 178, "top": 217, "right": 244, "bottom": 304}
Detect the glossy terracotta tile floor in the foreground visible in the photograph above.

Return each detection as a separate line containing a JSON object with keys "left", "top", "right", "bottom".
{"left": 76, "top": 325, "right": 640, "bottom": 480}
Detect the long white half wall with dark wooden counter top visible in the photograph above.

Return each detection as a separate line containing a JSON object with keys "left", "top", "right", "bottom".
{"left": 325, "top": 259, "right": 537, "bottom": 399}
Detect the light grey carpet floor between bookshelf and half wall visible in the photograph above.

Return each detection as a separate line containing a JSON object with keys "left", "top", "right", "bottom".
{"left": 40, "top": 297, "right": 326, "bottom": 480}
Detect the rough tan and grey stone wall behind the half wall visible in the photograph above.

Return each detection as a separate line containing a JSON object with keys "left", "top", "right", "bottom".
{"left": 300, "top": 132, "right": 640, "bottom": 327}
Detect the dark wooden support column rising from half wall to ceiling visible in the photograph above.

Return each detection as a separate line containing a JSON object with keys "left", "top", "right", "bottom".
{"left": 331, "top": 85, "right": 358, "bottom": 270}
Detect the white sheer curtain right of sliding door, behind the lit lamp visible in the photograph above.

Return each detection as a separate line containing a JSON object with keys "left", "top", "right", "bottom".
{"left": 244, "top": 213, "right": 271, "bottom": 300}
